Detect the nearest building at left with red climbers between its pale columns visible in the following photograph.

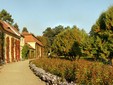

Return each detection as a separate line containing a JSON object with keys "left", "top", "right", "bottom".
{"left": 0, "top": 20, "right": 24, "bottom": 63}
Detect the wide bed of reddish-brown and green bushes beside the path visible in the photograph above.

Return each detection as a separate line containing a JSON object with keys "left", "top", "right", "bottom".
{"left": 33, "top": 58, "right": 113, "bottom": 85}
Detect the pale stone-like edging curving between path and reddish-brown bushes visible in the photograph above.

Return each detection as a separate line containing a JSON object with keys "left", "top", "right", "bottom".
{"left": 29, "top": 62, "right": 76, "bottom": 85}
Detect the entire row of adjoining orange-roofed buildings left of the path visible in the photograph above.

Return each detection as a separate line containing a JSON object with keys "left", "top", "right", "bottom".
{"left": 0, "top": 20, "right": 43, "bottom": 63}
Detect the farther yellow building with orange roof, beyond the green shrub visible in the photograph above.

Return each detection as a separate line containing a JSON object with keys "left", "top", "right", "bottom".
{"left": 22, "top": 32, "right": 43, "bottom": 58}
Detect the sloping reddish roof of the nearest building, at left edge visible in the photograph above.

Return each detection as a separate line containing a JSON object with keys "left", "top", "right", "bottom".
{"left": 0, "top": 20, "right": 21, "bottom": 37}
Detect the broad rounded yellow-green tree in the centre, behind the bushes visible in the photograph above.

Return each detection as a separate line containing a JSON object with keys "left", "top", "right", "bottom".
{"left": 52, "top": 26, "right": 88, "bottom": 59}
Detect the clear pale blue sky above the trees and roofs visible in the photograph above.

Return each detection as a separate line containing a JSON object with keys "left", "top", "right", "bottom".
{"left": 0, "top": 0, "right": 113, "bottom": 36}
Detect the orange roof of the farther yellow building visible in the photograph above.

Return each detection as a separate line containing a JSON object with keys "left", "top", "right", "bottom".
{"left": 22, "top": 32, "right": 43, "bottom": 46}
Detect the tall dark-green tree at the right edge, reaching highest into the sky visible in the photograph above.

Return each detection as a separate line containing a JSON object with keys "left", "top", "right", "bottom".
{"left": 90, "top": 6, "right": 113, "bottom": 64}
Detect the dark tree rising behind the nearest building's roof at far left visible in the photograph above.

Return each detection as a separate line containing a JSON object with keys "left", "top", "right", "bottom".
{"left": 0, "top": 9, "right": 13, "bottom": 25}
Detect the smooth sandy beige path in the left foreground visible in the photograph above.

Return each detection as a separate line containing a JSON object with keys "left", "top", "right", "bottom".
{"left": 0, "top": 60, "right": 45, "bottom": 85}
